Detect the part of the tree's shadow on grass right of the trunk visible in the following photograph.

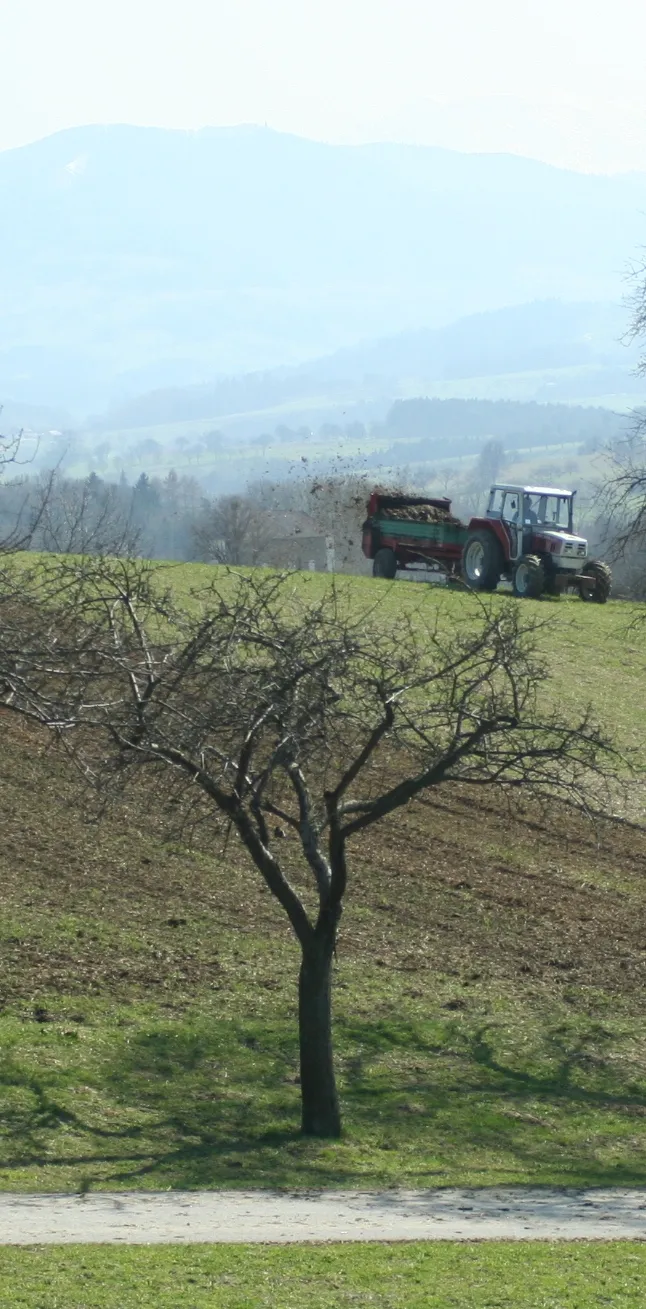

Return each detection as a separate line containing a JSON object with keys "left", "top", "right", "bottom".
{"left": 334, "top": 1020, "right": 646, "bottom": 1186}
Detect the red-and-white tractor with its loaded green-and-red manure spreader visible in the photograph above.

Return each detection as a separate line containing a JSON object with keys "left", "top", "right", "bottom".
{"left": 362, "top": 483, "right": 612, "bottom": 605}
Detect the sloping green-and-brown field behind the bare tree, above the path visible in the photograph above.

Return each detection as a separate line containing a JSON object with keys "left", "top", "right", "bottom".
{"left": 0, "top": 568, "right": 646, "bottom": 1193}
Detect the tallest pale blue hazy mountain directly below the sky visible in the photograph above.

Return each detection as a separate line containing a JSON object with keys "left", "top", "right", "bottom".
{"left": 0, "top": 127, "right": 646, "bottom": 414}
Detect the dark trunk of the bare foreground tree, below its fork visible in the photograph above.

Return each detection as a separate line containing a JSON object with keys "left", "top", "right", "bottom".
{"left": 298, "top": 932, "right": 341, "bottom": 1138}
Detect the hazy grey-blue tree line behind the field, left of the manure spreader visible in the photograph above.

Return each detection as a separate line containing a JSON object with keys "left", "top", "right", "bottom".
{"left": 0, "top": 469, "right": 369, "bottom": 572}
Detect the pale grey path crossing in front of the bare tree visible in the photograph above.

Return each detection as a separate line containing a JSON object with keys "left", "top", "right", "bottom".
{"left": 0, "top": 1187, "right": 646, "bottom": 1245}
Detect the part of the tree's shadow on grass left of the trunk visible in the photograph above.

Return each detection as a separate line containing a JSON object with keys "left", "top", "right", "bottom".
{"left": 0, "top": 1024, "right": 316, "bottom": 1187}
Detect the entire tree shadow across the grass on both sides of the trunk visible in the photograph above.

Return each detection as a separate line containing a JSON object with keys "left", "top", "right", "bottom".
{"left": 0, "top": 1020, "right": 646, "bottom": 1189}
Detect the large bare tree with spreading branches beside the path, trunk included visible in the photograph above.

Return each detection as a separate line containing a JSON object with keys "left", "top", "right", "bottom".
{"left": 0, "top": 559, "right": 612, "bottom": 1138}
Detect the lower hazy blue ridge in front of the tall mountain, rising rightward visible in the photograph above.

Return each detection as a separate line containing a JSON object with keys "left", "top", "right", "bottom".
{"left": 94, "top": 300, "right": 645, "bottom": 431}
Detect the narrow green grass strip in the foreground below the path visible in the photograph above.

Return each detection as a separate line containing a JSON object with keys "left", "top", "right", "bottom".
{"left": 0, "top": 1242, "right": 646, "bottom": 1309}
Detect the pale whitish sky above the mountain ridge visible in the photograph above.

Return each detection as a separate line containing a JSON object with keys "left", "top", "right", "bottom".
{"left": 0, "top": 0, "right": 646, "bottom": 173}
